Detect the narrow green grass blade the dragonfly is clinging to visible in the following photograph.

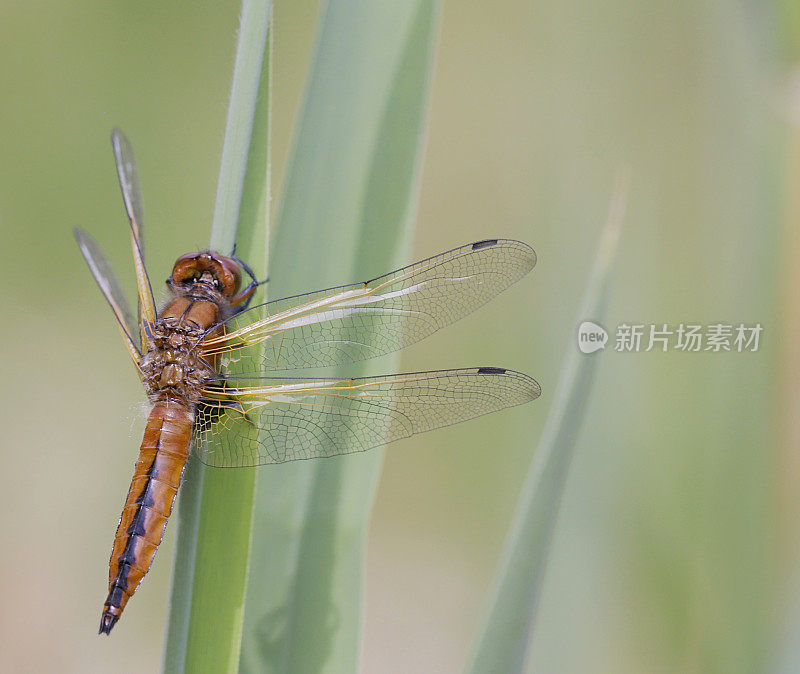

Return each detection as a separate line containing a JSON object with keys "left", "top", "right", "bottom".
{"left": 164, "top": 0, "right": 272, "bottom": 672}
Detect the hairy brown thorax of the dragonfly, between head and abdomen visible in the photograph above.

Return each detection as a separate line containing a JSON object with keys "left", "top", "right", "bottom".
{"left": 141, "top": 293, "right": 227, "bottom": 405}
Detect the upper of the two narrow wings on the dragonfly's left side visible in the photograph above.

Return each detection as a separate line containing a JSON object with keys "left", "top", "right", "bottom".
{"left": 111, "top": 129, "right": 156, "bottom": 346}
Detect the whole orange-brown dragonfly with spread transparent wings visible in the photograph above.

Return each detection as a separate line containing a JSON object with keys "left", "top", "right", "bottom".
{"left": 74, "top": 129, "right": 541, "bottom": 634}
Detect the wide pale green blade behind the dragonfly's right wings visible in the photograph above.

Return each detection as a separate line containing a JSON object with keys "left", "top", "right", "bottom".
{"left": 241, "top": 0, "right": 439, "bottom": 674}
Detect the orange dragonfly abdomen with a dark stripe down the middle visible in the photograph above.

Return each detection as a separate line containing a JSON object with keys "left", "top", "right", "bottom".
{"left": 100, "top": 398, "right": 194, "bottom": 634}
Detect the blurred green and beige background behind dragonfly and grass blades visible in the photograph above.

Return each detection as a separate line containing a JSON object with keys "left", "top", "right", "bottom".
{"left": 0, "top": 0, "right": 800, "bottom": 673}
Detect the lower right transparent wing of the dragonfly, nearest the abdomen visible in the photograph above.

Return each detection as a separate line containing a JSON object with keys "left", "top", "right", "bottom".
{"left": 193, "top": 367, "right": 541, "bottom": 467}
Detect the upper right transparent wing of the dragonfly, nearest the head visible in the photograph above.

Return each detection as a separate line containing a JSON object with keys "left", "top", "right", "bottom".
{"left": 203, "top": 239, "right": 536, "bottom": 372}
